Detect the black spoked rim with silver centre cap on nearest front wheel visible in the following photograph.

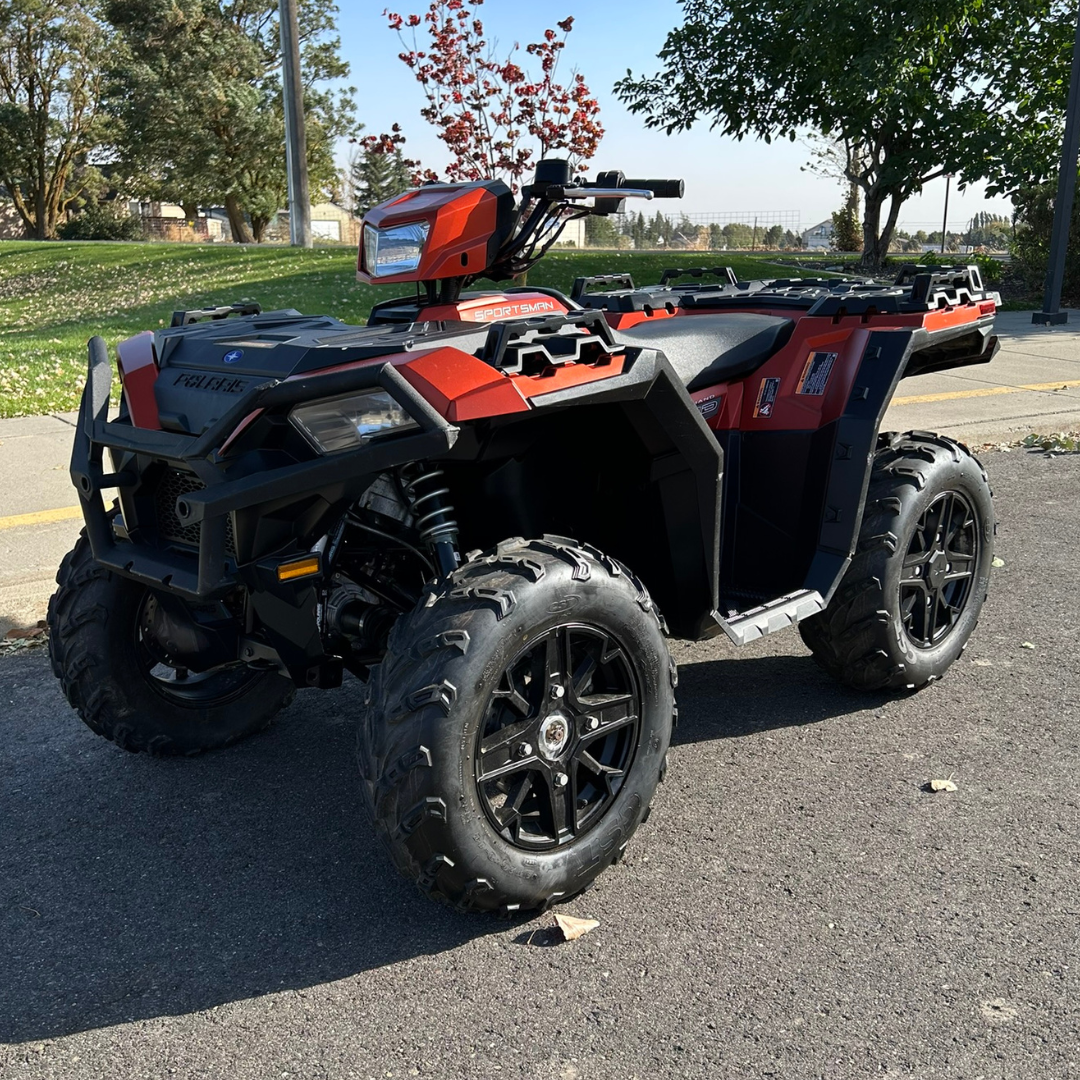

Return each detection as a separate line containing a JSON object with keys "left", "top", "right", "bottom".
{"left": 475, "top": 624, "right": 642, "bottom": 851}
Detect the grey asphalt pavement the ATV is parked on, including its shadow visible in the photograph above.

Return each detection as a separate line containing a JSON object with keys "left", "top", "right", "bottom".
{"left": 0, "top": 451, "right": 1080, "bottom": 1080}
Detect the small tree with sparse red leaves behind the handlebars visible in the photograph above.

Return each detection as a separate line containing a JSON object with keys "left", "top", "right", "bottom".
{"left": 363, "top": 0, "right": 604, "bottom": 191}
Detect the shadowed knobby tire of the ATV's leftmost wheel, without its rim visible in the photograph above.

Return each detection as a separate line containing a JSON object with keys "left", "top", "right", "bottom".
{"left": 49, "top": 534, "right": 295, "bottom": 757}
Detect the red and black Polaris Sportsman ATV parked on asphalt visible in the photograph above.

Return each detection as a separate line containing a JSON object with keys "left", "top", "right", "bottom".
{"left": 49, "top": 161, "right": 997, "bottom": 910}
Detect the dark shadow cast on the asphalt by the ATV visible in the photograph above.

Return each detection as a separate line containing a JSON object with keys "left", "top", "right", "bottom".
{"left": 0, "top": 654, "right": 874, "bottom": 1042}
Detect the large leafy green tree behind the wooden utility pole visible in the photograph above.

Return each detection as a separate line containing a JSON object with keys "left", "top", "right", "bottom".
{"left": 106, "top": 0, "right": 354, "bottom": 242}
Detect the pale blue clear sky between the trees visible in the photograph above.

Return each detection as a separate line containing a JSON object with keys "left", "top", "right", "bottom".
{"left": 338, "top": 0, "right": 1010, "bottom": 232}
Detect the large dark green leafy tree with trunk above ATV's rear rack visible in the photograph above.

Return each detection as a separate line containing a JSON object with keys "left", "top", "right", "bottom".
{"left": 616, "top": 0, "right": 1050, "bottom": 267}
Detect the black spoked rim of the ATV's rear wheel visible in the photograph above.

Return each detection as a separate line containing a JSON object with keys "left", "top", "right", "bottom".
{"left": 900, "top": 491, "right": 980, "bottom": 649}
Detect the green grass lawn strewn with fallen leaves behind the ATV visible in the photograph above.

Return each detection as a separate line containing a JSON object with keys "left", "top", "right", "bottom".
{"left": 0, "top": 241, "right": 814, "bottom": 417}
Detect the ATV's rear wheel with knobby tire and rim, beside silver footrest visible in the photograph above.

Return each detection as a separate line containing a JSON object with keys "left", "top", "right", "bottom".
{"left": 799, "top": 432, "right": 995, "bottom": 690}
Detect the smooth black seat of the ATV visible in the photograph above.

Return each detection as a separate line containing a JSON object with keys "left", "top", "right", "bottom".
{"left": 611, "top": 311, "right": 795, "bottom": 391}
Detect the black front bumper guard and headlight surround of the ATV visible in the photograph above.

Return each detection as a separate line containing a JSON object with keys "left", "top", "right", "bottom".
{"left": 71, "top": 337, "right": 458, "bottom": 599}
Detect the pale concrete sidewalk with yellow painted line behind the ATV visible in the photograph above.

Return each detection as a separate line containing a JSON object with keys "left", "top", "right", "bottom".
{"left": 0, "top": 311, "right": 1080, "bottom": 635}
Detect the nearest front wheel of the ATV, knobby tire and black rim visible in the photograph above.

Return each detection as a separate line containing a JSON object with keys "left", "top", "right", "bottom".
{"left": 359, "top": 537, "right": 675, "bottom": 912}
